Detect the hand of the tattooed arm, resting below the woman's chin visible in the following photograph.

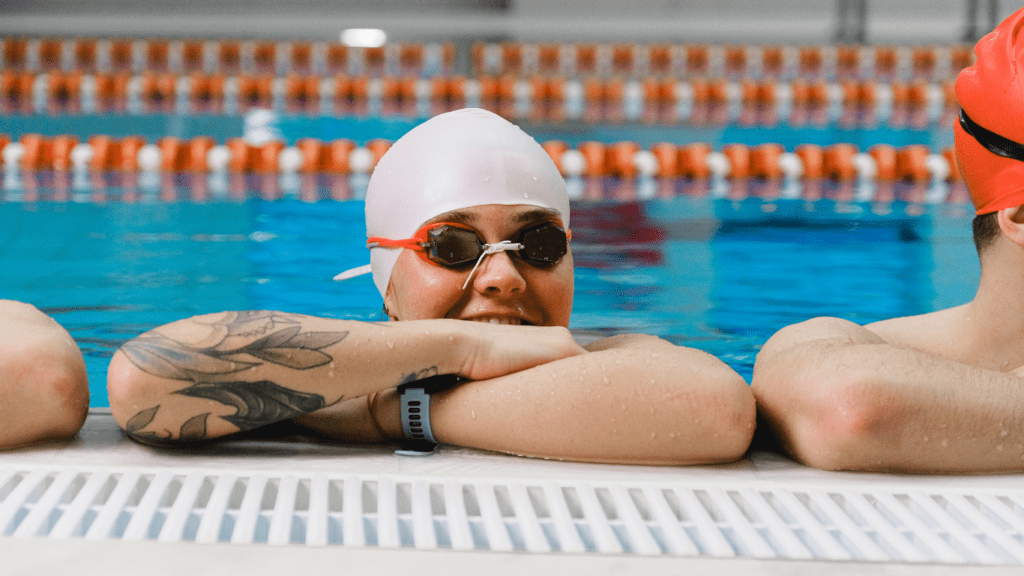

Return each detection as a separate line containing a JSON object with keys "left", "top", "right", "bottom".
{"left": 458, "top": 322, "right": 587, "bottom": 380}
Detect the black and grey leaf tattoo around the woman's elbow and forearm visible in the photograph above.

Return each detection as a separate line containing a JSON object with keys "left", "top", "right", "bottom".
{"left": 120, "top": 311, "right": 344, "bottom": 436}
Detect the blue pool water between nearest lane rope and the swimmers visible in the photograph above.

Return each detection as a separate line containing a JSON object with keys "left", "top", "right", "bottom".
{"left": 0, "top": 190, "right": 979, "bottom": 406}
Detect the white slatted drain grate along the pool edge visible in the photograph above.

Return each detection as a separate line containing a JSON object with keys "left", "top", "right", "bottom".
{"left": 0, "top": 467, "right": 1024, "bottom": 564}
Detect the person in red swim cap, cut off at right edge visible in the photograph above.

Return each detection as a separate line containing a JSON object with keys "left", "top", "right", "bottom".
{"left": 752, "top": 9, "right": 1024, "bottom": 472}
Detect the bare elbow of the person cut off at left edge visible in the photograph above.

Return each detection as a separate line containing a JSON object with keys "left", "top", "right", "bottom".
{"left": 0, "top": 300, "right": 89, "bottom": 450}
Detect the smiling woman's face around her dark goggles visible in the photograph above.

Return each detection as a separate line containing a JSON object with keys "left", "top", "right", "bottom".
{"left": 384, "top": 204, "right": 572, "bottom": 326}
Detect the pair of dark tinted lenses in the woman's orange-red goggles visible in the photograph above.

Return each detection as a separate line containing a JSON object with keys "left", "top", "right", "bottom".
{"left": 425, "top": 222, "right": 568, "bottom": 268}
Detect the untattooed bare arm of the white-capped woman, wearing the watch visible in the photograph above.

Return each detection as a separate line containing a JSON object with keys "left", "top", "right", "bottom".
{"left": 299, "top": 335, "right": 755, "bottom": 464}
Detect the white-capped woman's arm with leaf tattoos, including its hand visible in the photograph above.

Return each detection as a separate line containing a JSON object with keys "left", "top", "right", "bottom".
{"left": 108, "top": 311, "right": 584, "bottom": 444}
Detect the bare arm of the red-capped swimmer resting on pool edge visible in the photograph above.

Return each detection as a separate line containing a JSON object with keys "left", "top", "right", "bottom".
{"left": 752, "top": 319, "right": 1024, "bottom": 472}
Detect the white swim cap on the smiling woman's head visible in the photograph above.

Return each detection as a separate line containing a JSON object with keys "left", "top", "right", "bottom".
{"left": 339, "top": 109, "right": 569, "bottom": 296}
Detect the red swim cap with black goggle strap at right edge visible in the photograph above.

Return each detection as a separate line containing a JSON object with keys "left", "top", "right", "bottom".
{"left": 953, "top": 8, "right": 1024, "bottom": 214}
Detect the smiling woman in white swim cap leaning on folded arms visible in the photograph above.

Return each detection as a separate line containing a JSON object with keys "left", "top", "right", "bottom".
{"left": 108, "top": 110, "right": 755, "bottom": 464}
